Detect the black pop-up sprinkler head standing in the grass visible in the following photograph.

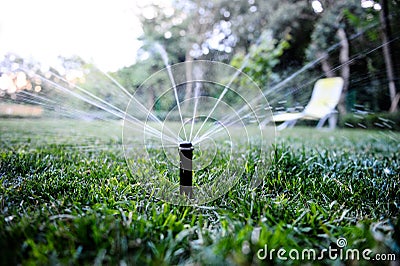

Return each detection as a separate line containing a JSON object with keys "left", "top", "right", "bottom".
{"left": 179, "top": 142, "right": 194, "bottom": 198}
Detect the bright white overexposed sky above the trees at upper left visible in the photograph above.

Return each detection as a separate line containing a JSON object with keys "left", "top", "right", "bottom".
{"left": 0, "top": 0, "right": 142, "bottom": 71}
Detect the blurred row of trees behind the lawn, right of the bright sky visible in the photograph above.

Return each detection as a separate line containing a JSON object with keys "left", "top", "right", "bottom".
{"left": 118, "top": 0, "right": 400, "bottom": 113}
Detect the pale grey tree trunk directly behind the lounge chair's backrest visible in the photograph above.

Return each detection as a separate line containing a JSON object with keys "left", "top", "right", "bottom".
{"left": 336, "top": 28, "right": 350, "bottom": 115}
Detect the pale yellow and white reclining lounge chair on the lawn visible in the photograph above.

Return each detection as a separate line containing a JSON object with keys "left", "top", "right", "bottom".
{"left": 273, "top": 77, "right": 344, "bottom": 130}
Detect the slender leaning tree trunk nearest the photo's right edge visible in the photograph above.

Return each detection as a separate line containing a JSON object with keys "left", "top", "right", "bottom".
{"left": 379, "top": 0, "right": 398, "bottom": 112}
